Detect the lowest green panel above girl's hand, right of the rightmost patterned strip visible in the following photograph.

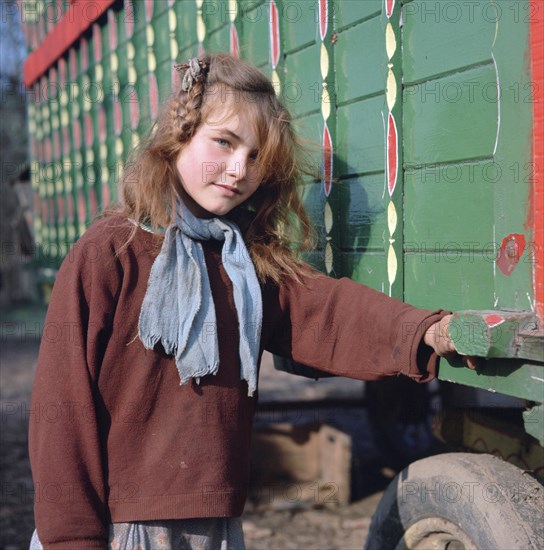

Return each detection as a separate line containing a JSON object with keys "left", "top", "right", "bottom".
{"left": 404, "top": 256, "right": 495, "bottom": 310}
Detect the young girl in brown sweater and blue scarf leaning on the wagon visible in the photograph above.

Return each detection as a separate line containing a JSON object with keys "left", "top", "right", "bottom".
{"left": 30, "top": 54, "right": 472, "bottom": 550}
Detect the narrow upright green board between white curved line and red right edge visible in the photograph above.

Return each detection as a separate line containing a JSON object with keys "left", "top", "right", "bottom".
{"left": 494, "top": 1, "right": 536, "bottom": 309}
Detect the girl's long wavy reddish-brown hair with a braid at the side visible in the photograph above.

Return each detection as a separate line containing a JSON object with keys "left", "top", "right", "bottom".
{"left": 107, "top": 53, "right": 317, "bottom": 283}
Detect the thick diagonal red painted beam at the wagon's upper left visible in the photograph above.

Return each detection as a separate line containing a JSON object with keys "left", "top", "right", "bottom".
{"left": 23, "top": 0, "right": 115, "bottom": 87}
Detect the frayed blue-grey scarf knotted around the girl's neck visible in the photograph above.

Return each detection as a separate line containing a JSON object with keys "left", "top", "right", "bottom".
{"left": 138, "top": 203, "right": 263, "bottom": 395}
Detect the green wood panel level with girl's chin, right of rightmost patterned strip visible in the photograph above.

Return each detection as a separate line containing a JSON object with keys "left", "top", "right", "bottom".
{"left": 404, "top": 161, "right": 498, "bottom": 245}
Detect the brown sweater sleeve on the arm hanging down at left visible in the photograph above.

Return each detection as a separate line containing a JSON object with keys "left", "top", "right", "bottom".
{"left": 29, "top": 221, "right": 120, "bottom": 550}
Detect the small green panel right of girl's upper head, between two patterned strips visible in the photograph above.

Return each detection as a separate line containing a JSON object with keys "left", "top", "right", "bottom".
{"left": 281, "top": 45, "right": 322, "bottom": 117}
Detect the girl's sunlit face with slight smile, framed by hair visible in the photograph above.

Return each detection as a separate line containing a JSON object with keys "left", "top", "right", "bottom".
{"left": 176, "top": 104, "right": 260, "bottom": 218}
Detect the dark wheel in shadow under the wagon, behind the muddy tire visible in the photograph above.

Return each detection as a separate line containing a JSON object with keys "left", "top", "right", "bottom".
{"left": 365, "top": 377, "right": 440, "bottom": 470}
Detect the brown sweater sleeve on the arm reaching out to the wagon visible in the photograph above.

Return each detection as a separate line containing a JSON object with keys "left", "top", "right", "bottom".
{"left": 263, "top": 270, "right": 448, "bottom": 382}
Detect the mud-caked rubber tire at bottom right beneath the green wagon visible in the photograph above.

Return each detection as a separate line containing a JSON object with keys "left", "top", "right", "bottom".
{"left": 365, "top": 453, "right": 544, "bottom": 550}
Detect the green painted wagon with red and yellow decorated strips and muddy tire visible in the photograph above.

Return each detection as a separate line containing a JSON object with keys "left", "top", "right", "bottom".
{"left": 20, "top": 0, "right": 544, "bottom": 549}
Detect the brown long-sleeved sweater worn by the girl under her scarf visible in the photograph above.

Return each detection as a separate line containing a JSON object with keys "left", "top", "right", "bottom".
{"left": 30, "top": 216, "right": 445, "bottom": 550}
